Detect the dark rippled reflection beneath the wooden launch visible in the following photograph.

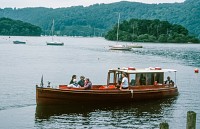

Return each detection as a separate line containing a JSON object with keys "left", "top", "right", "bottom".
{"left": 35, "top": 97, "right": 177, "bottom": 128}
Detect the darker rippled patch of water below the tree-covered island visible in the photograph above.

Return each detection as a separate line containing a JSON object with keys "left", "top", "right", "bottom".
{"left": 134, "top": 44, "right": 200, "bottom": 67}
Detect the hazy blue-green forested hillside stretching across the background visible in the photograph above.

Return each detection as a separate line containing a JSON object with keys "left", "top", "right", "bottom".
{"left": 0, "top": 0, "right": 200, "bottom": 38}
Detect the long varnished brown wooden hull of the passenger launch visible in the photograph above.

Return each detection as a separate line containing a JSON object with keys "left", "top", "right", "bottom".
{"left": 36, "top": 86, "right": 178, "bottom": 105}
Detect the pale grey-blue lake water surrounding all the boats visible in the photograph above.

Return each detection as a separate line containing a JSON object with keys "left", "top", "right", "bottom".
{"left": 0, "top": 36, "right": 200, "bottom": 129}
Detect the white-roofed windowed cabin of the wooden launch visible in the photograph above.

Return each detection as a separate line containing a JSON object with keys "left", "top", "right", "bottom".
{"left": 107, "top": 67, "right": 176, "bottom": 87}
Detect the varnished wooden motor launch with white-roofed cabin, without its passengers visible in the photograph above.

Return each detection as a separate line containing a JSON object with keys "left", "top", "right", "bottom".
{"left": 36, "top": 67, "right": 178, "bottom": 105}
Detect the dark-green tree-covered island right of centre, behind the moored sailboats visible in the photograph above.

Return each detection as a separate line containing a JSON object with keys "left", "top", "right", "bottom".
{"left": 105, "top": 19, "right": 200, "bottom": 43}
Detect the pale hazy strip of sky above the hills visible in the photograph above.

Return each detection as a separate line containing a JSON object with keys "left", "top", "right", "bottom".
{"left": 0, "top": 0, "right": 185, "bottom": 8}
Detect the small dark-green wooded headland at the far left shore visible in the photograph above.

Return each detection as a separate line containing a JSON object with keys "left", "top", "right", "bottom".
{"left": 0, "top": 18, "right": 42, "bottom": 36}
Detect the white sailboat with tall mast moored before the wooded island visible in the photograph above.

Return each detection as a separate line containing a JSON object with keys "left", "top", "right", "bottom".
{"left": 110, "top": 13, "right": 131, "bottom": 51}
